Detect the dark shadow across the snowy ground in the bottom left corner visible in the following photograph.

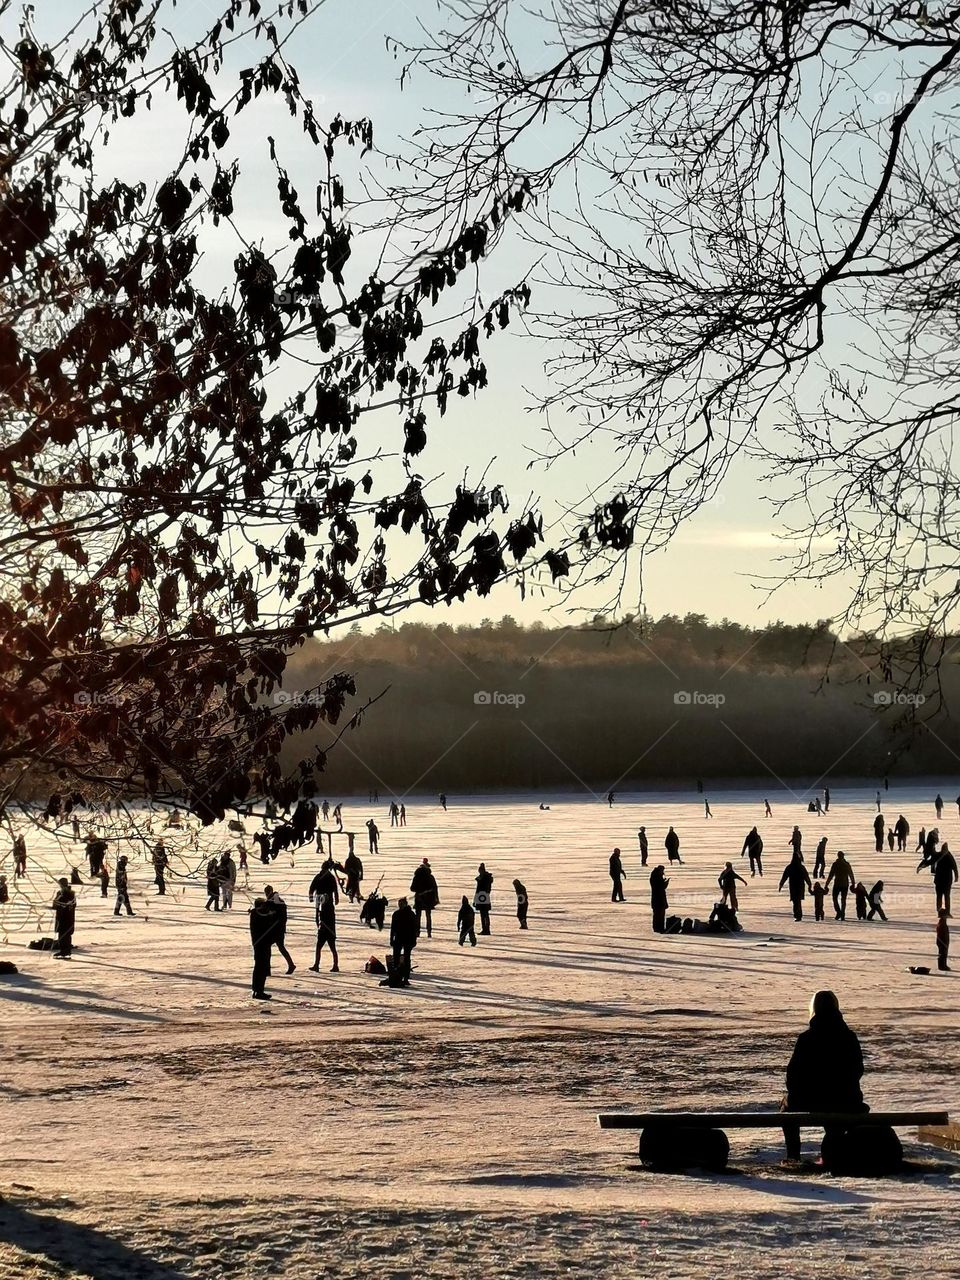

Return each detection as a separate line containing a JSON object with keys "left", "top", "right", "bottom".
{"left": 0, "top": 1201, "right": 186, "bottom": 1280}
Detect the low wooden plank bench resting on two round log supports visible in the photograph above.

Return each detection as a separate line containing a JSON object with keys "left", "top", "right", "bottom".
{"left": 596, "top": 1111, "right": 950, "bottom": 1172}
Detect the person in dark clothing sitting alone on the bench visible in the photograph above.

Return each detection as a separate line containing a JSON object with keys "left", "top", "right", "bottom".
{"left": 783, "top": 991, "right": 869, "bottom": 1160}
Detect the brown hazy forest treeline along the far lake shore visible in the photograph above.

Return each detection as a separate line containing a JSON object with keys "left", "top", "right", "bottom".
{"left": 276, "top": 614, "right": 960, "bottom": 795}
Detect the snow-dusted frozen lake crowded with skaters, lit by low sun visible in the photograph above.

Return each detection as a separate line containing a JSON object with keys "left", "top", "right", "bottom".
{"left": 0, "top": 783, "right": 960, "bottom": 1277}
